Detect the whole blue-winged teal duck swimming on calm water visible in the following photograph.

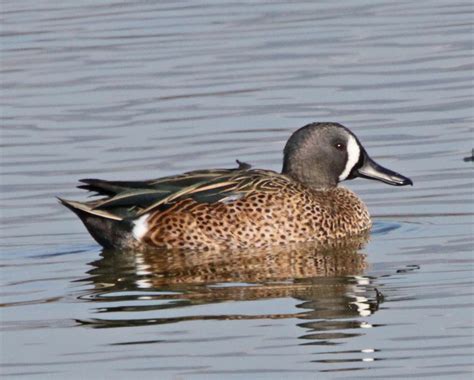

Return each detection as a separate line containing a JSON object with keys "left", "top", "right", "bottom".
{"left": 60, "top": 123, "right": 412, "bottom": 249}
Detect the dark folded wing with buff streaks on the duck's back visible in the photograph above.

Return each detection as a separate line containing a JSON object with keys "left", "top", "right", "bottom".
{"left": 74, "top": 160, "right": 282, "bottom": 219}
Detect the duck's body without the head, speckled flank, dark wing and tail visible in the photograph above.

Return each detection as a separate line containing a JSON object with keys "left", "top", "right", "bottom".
{"left": 60, "top": 168, "right": 371, "bottom": 249}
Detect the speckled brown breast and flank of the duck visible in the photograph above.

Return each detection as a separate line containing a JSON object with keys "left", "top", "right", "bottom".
{"left": 142, "top": 179, "right": 371, "bottom": 250}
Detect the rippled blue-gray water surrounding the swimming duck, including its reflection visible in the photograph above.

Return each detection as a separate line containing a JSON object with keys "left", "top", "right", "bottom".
{"left": 0, "top": 0, "right": 474, "bottom": 379}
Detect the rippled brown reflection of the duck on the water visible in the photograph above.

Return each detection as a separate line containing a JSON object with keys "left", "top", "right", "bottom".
{"left": 79, "top": 237, "right": 381, "bottom": 344}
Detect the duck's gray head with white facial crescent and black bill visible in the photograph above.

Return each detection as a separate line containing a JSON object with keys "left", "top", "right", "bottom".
{"left": 282, "top": 123, "right": 413, "bottom": 189}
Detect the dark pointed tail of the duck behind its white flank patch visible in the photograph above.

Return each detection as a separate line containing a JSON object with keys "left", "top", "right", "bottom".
{"left": 58, "top": 197, "right": 133, "bottom": 248}
